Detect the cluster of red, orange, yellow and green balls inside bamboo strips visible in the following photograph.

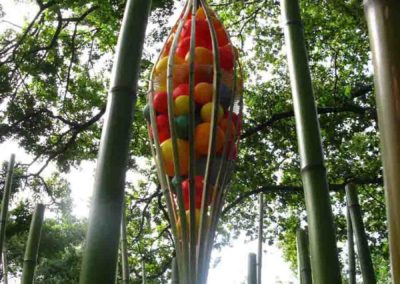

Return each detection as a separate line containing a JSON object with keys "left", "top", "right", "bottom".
{"left": 144, "top": 7, "right": 241, "bottom": 221}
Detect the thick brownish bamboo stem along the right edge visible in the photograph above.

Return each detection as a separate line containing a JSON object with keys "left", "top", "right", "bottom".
{"left": 364, "top": 0, "right": 400, "bottom": 284}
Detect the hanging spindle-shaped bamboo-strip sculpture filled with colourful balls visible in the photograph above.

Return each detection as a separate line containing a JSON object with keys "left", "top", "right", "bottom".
{"left": 144, "top": 0, "right": 242, "bottom": 284}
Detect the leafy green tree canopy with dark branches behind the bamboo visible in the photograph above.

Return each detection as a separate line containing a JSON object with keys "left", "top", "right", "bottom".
{"left": 0, "top": 0, "right": 389, "bottom": 283}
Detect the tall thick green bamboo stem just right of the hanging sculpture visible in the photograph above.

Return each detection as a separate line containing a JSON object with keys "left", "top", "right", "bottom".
{"left": 281, "top": 0, "right": 341, "bottom": 284}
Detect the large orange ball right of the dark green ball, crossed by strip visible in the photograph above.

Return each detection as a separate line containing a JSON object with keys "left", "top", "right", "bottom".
{"left": 194, "top": 122, "right": 224, "bottom": 155}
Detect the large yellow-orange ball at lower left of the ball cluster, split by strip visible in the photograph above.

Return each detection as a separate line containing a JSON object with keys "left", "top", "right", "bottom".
{"left": 160, "top": 138, "right": 189, "bottom": 177}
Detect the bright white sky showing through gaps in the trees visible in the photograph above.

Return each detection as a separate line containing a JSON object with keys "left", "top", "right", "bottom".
{"left": 0, "top": 0, "right": 296, "bottom": 284}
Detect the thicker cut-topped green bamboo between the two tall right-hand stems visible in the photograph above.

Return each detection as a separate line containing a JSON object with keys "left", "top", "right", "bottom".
{"left": 346, "top": 183, "right": 376, "bottom": 284}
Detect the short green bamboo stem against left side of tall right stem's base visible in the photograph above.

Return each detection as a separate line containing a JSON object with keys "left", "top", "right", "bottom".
{"left": 296, "top": 229, "right": 312, "bottom": 284}
